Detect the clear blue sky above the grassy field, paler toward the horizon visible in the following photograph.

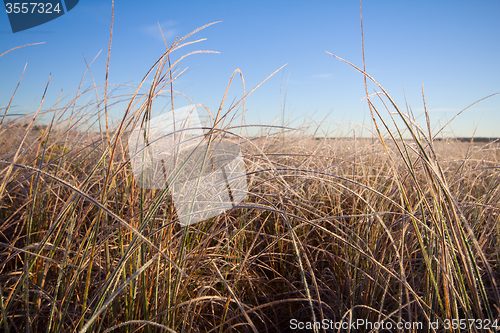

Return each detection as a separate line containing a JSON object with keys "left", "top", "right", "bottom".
{"left": 0, "top": 0, "right": 500, "bottom": 137}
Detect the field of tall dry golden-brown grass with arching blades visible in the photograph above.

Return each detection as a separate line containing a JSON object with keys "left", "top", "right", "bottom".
{"left": 0, "top": 22, "right": 500, "bottom": 332}
